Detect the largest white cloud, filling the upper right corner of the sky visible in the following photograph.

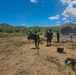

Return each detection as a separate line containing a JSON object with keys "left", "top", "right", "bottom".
{"left": 61, "top": 0, "right": 76, "bottom": 17}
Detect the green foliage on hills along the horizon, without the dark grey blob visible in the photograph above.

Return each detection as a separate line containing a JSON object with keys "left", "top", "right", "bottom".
{"left": 0, "top": 23, "right": 76, "bottom": 35}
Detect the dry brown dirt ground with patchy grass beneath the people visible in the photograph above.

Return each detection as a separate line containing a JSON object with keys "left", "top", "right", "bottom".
{"left": 0, "top": 37, "right": 76, "bottom": 75}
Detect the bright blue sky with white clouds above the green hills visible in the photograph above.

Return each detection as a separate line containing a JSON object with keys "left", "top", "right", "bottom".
{"left": 0, "top": 0, "right": 76, "bottom": 27}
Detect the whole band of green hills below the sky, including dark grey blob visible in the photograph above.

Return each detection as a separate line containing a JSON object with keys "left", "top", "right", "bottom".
{"left": 0, "top": 23, "right": 76, "bottom": 36}
